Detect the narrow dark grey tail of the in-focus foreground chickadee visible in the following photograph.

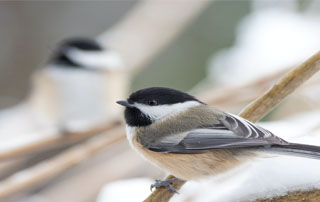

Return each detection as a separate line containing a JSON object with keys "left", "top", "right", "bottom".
{"left": 267, "top": 143, "right": 320, "bottom": 159}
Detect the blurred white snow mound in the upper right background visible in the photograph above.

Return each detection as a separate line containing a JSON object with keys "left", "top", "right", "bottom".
{"left": 208, "top": 8, "right": 320, "bottom": 85}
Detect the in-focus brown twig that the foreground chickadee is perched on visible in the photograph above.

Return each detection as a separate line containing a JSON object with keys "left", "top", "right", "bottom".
{"left": 144, "top": 52, "right": 320, "bottom": 202}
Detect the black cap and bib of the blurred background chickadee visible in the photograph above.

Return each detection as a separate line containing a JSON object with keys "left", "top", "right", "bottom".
{"left": 48, "top": 37, "right": 104, "bottom": 69}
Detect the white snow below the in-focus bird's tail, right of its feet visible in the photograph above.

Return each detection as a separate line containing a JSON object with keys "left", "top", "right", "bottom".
{"left": 172, "top": 157, "right": 320, "bottom": 202}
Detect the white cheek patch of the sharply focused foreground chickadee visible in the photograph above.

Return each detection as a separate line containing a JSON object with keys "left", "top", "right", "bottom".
{"left": 134, "top": 101, "right": 201, "bottom": 121}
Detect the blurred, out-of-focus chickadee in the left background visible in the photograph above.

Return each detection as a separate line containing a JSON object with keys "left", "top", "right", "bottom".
{"left": 29, "top": 37, "right": 127, "bottom": 130}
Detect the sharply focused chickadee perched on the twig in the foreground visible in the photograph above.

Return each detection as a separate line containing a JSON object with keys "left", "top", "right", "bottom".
{"left": 117, "top": 87, "right": 320, "bottom": 191}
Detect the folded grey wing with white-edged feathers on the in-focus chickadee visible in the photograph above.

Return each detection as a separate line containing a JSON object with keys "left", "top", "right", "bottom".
{"left": 144, "top": 114, "right": 288, "bottom": 153}
